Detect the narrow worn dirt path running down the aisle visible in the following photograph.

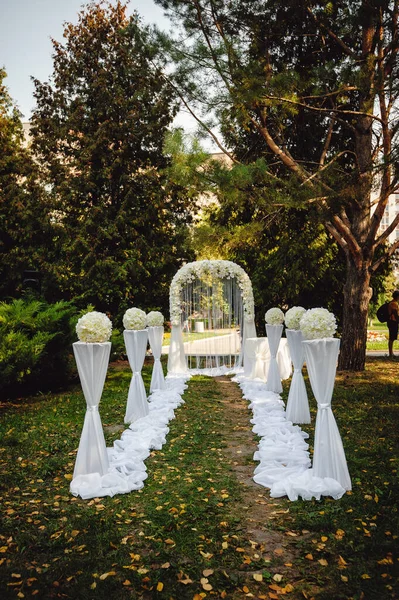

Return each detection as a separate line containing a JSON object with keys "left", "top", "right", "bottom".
{"left": 215, "top": 376, "right": 312, "bottom": 600}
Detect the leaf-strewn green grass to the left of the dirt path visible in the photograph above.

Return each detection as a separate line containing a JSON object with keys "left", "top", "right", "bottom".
{"left": 0, "top": 360, "right": 250, "bottom": 599}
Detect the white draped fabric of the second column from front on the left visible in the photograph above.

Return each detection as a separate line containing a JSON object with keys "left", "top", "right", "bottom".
{"left": 123, "top": 329, "right": 149, "bottom": 423}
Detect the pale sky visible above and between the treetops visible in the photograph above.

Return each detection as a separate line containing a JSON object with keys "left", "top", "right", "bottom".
{"left": 0, "top": 0, "right": 200, "bottom": 138}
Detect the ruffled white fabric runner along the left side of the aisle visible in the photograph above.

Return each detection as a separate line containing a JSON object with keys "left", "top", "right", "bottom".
{"left": 70, "top": 375, "right": 190, "bottom": 500}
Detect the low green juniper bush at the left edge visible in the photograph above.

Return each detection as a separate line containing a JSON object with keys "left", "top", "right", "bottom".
{"left": 0, "top": 298, "right": 76, "bottom": 397}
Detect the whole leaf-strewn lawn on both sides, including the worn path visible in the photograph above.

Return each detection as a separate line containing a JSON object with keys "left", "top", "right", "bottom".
{"left": 0, "top": 358, "right": 399, "bottom": 600}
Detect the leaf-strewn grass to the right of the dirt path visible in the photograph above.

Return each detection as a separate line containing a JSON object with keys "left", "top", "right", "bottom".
{"left": 283, "top": 358, "right": 399, "bottom": 600}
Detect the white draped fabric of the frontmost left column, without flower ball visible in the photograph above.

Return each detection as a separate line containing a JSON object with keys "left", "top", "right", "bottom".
{"left": 71, "top": 342, "right": 111, "bottom": 493}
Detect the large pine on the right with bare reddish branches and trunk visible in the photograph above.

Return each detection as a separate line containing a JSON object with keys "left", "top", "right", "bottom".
{"left": 157, "top": 0, "right": 399, "bottom": 370}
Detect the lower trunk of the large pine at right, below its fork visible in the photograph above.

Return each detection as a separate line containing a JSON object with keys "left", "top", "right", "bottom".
{"left": 338, "top": 258, "right": 372, "bottom": 371}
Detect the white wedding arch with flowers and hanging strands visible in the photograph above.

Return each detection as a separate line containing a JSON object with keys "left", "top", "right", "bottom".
{"left": 168, "top": 260, "right": 256, "bottom": 374}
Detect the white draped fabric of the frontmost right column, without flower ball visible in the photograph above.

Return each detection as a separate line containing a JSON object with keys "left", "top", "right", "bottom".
{"left": 303, "top": 338, "right": 352, "bottom": 490}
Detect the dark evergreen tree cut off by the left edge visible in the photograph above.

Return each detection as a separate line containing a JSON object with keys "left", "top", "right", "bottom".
{"left": 0, "top": 69, "right": 57, "bottom": 299}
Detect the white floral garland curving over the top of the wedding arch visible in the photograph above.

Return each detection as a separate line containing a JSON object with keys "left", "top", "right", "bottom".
{"left": 169, "top": 260, "right": 255, "bottom": 325}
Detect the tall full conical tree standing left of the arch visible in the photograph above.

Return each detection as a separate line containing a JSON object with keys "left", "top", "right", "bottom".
{"left": 32, "top": 2, "right": 194, "bottom": 315}
